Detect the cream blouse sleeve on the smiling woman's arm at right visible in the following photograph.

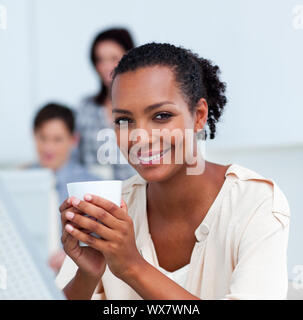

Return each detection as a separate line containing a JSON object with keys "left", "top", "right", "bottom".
{"left": 225, "top": 197, "right": 289, "bottom": 300}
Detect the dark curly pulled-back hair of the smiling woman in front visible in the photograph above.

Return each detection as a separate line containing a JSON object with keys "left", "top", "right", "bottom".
{"left": 113, "top": 42, "right": 227, "bottom": 139}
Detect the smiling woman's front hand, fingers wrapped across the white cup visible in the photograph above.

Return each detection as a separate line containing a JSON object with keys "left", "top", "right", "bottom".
{"left": 65, "top": 195, "right": 143, "bottom": 279}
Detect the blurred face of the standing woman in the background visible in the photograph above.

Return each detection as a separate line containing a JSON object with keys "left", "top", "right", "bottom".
{"left": 95, "top": 40, "right": 125, "bottom": 88}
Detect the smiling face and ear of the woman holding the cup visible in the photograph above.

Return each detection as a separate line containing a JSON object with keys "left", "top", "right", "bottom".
{"left": 112, "top": 66, "right": 207, "bottom": 182}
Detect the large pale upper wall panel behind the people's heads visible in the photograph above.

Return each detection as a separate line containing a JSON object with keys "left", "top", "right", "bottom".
{"left": 35, "top": 0, "right": 303, "bottom": 146}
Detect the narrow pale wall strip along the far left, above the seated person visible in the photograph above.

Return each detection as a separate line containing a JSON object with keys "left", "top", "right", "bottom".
{"left": 0, "top": 0, "right": 34, "bottom": 163}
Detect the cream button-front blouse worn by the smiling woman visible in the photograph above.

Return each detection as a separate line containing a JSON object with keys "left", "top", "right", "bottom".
{"left": 58, "top": 164, "right": 290, "bottom": 300}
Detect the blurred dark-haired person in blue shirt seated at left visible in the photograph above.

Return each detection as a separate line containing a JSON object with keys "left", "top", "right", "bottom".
{"left": 30, "top": 103, "right": 98, "bottom": 272}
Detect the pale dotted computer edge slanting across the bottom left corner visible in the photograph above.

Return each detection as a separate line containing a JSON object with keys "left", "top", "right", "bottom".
{"left": 0, "top": 182, "right": 65, "bottom": 300}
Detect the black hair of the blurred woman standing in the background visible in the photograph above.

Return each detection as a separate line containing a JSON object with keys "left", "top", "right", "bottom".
{"left": 90, "top": 28, "right": 135, "bottom": 105}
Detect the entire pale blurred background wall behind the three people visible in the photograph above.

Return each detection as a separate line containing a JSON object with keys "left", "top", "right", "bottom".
{"left": 0, "top": 0, "right": 303, "bottom": 296}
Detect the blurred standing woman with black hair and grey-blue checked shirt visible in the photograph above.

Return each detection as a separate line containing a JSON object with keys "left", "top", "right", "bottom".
{"left": 75, "top": 28, "right": 135, "bottom": 180}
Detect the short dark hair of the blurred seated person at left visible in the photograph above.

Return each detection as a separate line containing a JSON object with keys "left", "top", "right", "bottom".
{"left": 34, "top": 103, "right": 75, "bottom": 134}
